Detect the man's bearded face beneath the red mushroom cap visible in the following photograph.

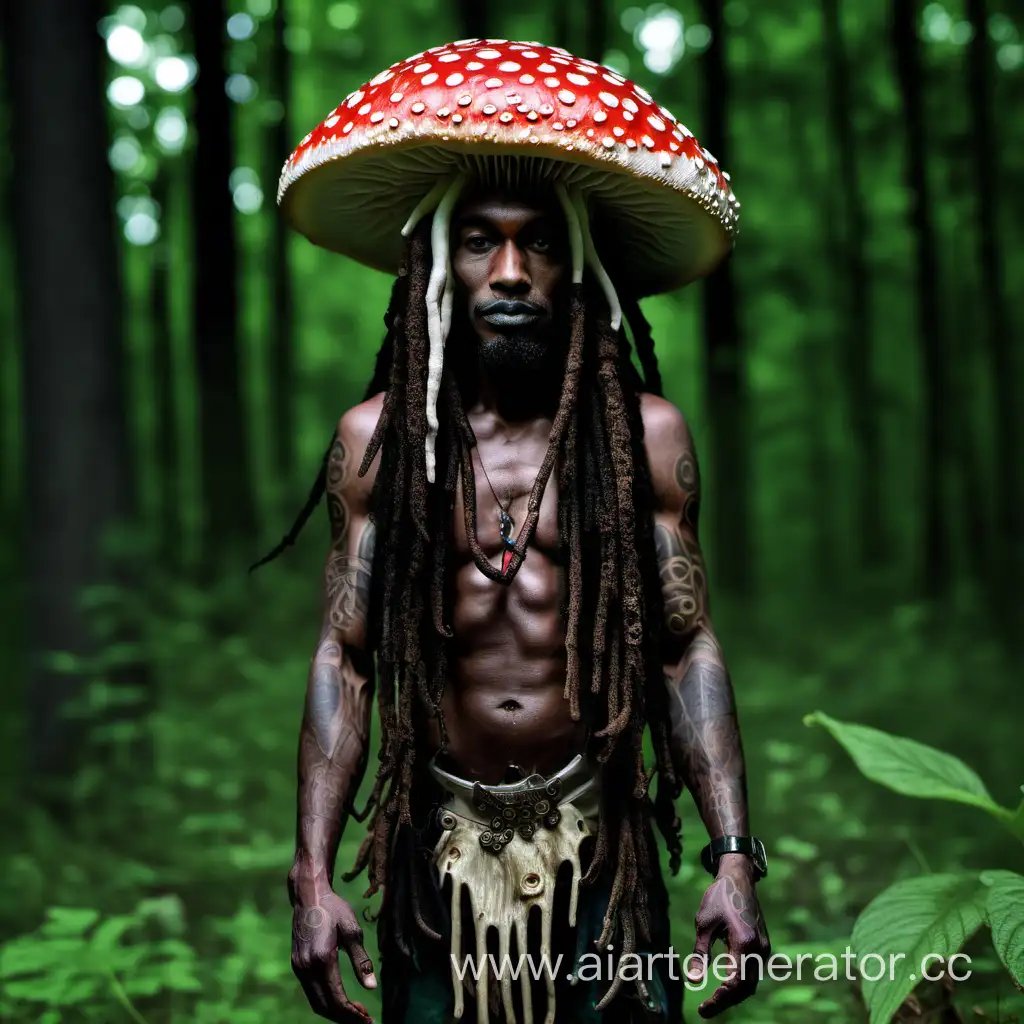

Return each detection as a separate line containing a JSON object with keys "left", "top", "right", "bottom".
{"left": 452, "top": 194, "right": 570, "bottom": 372}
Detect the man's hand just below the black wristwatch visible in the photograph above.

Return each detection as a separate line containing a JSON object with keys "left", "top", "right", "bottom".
{"left": 687, "top": 853, "right": 771, "bottom": 1018}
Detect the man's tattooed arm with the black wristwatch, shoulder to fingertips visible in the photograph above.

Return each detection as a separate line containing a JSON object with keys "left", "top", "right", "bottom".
{"left": 644, "top": 396, "right": 770, "bottom": 1017}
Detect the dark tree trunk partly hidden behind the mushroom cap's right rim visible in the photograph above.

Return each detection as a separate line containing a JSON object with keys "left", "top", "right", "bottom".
{"left": 699, "top": 0, "right": 753, "bottom": 594}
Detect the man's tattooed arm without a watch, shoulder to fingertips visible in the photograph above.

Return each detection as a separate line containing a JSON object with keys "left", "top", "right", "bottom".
{"left": 288, "top": 411, "right": 376, "bottom": 1021}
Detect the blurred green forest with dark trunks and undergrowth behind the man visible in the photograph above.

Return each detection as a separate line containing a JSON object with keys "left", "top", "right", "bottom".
{"left": 0, "top": 0, "right": 1024, "bottom": 1024}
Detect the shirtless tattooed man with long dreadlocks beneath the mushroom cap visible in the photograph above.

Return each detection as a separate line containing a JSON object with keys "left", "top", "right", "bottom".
{"left": 288, "top": 180, "right": 769, "bottom": 1022}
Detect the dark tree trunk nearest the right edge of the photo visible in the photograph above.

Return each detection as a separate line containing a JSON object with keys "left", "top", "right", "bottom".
{"left": 967, "top": 0, "right": 1024, "bottom": 607}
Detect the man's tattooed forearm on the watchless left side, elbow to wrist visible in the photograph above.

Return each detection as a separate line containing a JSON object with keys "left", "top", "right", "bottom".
{"left": 293, "top": 630, "right": 373, "bottom": 886}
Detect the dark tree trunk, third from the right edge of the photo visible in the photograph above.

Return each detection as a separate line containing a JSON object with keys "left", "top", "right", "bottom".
{"left": 821, "top": 0, "right": 889, "bottom": 567}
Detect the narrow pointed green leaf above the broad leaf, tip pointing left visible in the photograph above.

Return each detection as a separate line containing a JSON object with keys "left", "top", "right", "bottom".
{"left": 804, "top": 712, "right": 1013, "bottom": 824}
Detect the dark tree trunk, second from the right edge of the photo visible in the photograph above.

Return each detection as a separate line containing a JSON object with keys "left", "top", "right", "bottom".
{"left": 892, "top": 0, "right": 950, "bottom": 599}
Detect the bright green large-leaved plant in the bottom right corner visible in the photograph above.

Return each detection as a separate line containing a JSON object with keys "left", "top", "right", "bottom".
{"left": 804, "top": 712, "right": 1024, "bottom": 1024}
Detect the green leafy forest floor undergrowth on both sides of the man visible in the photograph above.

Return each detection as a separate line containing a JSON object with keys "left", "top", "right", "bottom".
{"left": 0, "top": 564, "right": 1024, "bottom": 1024}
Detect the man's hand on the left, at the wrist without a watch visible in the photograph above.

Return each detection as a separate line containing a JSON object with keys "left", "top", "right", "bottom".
{"left": 289, "top": 879, "right": 377, "bottom": 1024}
